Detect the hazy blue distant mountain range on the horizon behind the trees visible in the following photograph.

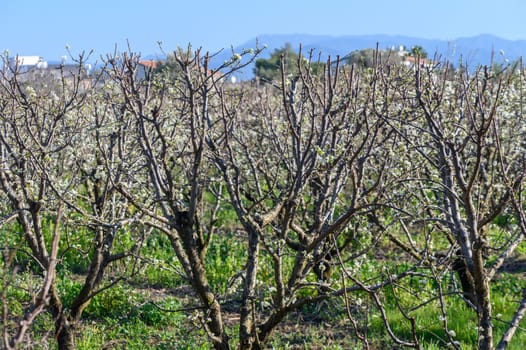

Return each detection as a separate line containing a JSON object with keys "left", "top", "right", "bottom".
{"left": 208, "top": 34, "right": 526, "bottom": 79}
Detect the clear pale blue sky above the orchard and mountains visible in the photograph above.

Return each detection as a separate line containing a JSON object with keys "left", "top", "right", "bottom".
{"left": 4, "top": 0, "right": 526, "bottom": 60}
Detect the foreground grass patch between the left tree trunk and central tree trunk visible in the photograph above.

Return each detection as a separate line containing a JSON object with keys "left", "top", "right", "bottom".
{"left": 69, "top": 286, "right": 208, "bottom": 350}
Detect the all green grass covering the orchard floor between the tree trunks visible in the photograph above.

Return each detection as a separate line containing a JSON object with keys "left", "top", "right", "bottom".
{"left": 2, "top": 217, "right": 526, "bottom": 350}
